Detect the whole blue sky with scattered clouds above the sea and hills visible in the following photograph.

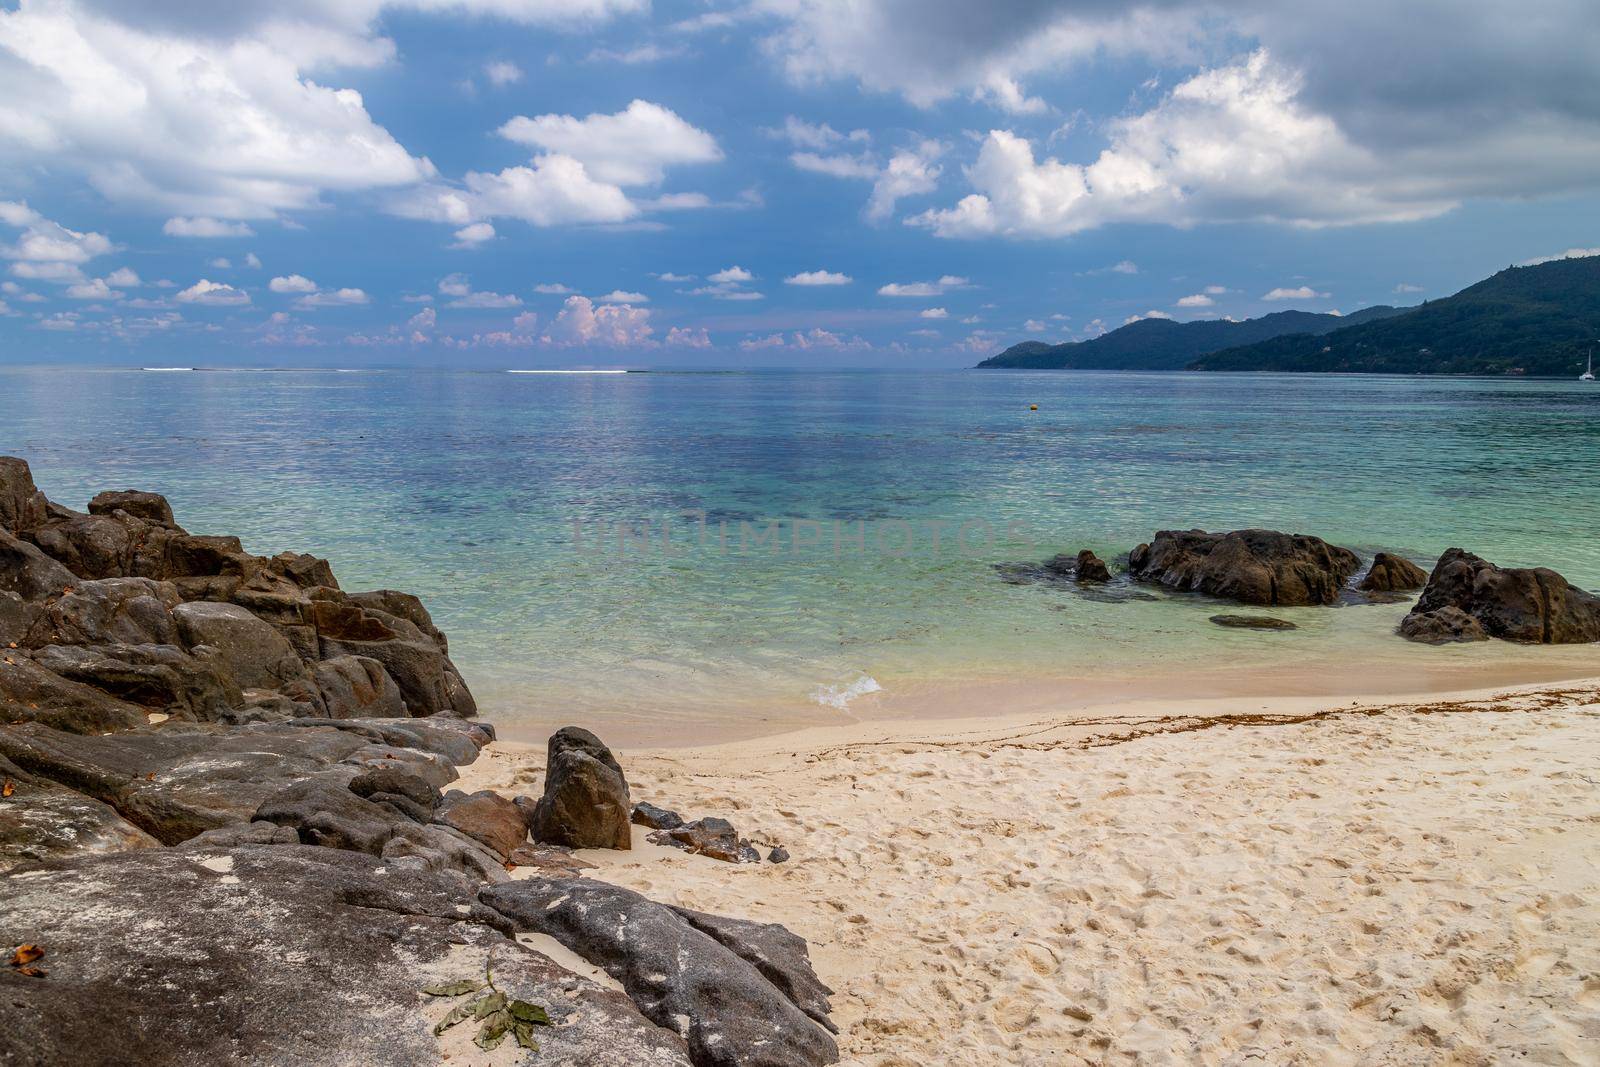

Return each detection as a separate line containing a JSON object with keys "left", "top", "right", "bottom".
{"left": 0, "top": 0, "right": 1600, "bottom": 368}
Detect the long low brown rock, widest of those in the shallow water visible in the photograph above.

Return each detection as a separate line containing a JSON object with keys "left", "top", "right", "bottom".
{"left": 1128, "top": 530, "right": 1362, "bottom": 606}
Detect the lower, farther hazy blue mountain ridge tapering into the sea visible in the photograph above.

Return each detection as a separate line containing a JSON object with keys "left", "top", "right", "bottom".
{"left": 978, "top": 306, "right": 1410, "bottom": 371}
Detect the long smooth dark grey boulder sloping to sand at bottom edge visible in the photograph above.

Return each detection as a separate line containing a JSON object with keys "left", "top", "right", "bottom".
{"left": 478, "top": 878, "right": 838, "bottom": 1067}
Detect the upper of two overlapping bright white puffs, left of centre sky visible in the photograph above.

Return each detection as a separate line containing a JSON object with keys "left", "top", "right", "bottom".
{"left": 499, "top": 99, "right": 722, "bottom": 186}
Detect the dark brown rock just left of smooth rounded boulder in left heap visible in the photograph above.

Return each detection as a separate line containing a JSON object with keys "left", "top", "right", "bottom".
{"left": 34, "top": 645, "right": 242, "bottom": 721}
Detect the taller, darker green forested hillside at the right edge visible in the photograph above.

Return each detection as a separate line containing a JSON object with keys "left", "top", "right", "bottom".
{"left": 1192, "top": 256, "right": 1600, "bottom": 378}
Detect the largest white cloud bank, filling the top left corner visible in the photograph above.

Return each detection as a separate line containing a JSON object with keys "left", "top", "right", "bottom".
{"left": 0, "top": 0, "right": 645, "bottom": 219}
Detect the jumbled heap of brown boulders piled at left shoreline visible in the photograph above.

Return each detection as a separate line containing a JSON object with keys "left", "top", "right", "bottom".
{"left": 0, "top": 456, "right": 477, "bottom": 733}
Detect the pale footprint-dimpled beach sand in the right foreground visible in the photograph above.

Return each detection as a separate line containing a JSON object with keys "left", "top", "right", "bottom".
{"left": 464, "top": 680, "right": 1600, "bottom": 1067}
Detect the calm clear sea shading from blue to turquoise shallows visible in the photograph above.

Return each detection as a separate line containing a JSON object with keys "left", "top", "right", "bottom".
{"left": 0, "top": 370, "right": 1600, "bottom": 739}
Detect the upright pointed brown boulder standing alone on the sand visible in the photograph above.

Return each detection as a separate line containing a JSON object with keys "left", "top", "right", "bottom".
{"left": 533, "top": 726, "right": 634, "bottom": 849}
